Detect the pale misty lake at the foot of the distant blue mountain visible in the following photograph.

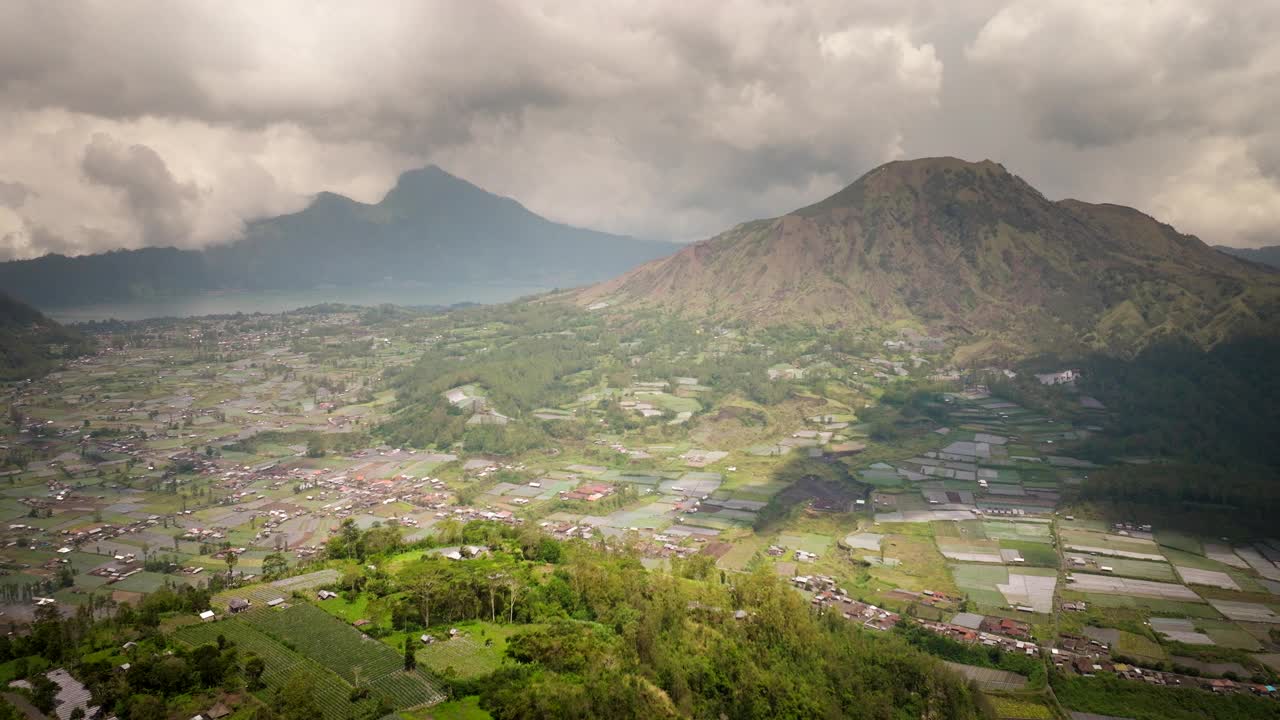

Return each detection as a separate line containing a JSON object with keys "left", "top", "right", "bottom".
{"left": 41, "top": 284, "right": 550, "bottom": 323}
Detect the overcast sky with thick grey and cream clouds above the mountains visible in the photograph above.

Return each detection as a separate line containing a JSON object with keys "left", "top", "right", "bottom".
{"left": 0, "top": 0, "right": 1280, "bottom": 258}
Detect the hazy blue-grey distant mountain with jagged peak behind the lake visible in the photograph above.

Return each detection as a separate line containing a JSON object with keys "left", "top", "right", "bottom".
{"left": 0, "top": 165, "right": 675, "bottom": 307}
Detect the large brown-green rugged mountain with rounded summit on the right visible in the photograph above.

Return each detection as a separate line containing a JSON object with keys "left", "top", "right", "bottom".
{"left": 572, "top": 158, "right": 1280, "bottom": 356}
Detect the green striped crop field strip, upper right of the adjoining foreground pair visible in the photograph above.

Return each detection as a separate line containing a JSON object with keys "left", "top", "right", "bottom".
{"left": 243, "top": 603, "right": 444, "bottom": 707}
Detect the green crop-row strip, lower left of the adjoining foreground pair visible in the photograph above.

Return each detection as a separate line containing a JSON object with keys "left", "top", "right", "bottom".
{"left": 177, "top": 620, "right": 371, "bottom": 720}
